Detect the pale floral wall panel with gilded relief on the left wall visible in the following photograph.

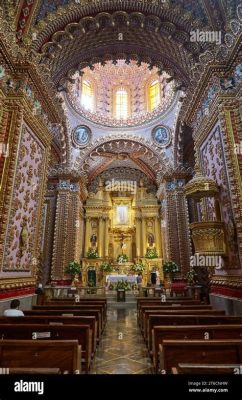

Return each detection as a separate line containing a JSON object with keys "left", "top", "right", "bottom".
{"left": 2, "top": 124, "right": 44, "bottom": 272}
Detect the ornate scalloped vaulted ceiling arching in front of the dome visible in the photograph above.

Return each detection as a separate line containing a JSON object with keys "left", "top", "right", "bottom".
{"left": 18, "top": 0, "right": 237, "bottom": 85}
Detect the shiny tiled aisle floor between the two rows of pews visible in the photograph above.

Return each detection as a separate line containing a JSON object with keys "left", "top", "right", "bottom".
{"left": 91, "top": 304, "right": 152, "bottom": 375}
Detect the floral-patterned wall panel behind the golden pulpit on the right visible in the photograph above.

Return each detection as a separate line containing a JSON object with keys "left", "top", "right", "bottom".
{"left": 200, "top": 123, "right": 240, "bottom": 269}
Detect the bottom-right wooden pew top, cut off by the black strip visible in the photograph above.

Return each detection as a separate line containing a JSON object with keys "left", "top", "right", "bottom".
{"left": 171, "top": 363, "right": 241, "bottom": 375}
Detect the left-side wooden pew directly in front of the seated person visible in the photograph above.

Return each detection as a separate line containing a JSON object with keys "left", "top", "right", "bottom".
{"left": 32, "top": 304, "right": 106, "bottom": 331}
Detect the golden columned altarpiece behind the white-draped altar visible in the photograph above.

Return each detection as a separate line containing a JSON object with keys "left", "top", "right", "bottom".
{"left": 82, "top": 180, "right": 163, "bottom": 286}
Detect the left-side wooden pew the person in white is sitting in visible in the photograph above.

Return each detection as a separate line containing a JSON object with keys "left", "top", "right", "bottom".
{"left": 0, "top": 315, "right": 97, "bottom": 357}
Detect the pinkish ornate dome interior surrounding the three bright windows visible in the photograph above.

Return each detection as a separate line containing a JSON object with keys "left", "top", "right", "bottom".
{"left": 66, "top": 60, "right": 175, "bottom": 127}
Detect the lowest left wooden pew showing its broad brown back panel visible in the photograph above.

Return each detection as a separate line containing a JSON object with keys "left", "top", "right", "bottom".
{"left": 0, "top": 340, "right": 81, "bottom": 374}
